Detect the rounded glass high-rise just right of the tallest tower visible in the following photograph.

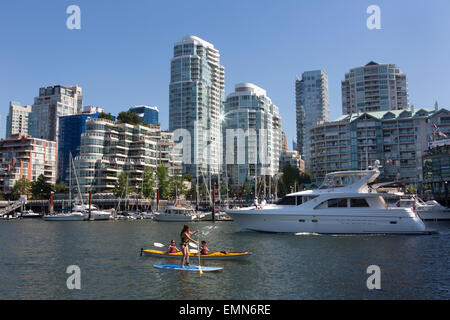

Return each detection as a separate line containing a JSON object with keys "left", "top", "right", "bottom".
{"left": 222, "top": 83, "right": 282, "bottom": 186}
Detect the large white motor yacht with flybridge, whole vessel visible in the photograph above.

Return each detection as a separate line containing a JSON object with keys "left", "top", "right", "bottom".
{"left": 226, "top": 167, "right": 431, "bottom": 234}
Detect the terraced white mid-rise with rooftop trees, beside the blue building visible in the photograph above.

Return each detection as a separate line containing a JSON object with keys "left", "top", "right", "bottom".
{"left": 73, "top": 118, "right": 182, "bottom": 193}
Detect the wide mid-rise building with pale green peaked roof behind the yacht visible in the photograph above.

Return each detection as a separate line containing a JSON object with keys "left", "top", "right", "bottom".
{"left": 310, "top": 109, "right": 450, "bottom": 184}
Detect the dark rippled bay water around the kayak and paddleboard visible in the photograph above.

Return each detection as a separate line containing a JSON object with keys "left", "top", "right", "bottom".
{"left": 0, "top": 220, "right": 450, "bottom": 300}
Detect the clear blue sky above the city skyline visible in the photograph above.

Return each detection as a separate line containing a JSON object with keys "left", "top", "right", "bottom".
{"left": 0, "top": 0, "right": 450, "bottom": 144}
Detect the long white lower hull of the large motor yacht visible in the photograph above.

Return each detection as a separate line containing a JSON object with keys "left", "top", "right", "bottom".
{"left": 226, "top": 209, "right": 429, "bottom": 234}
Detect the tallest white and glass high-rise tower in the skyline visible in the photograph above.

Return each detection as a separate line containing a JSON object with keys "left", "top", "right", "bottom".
{"left": 169, "top": 36, "right": 225, "bottom": 177}
